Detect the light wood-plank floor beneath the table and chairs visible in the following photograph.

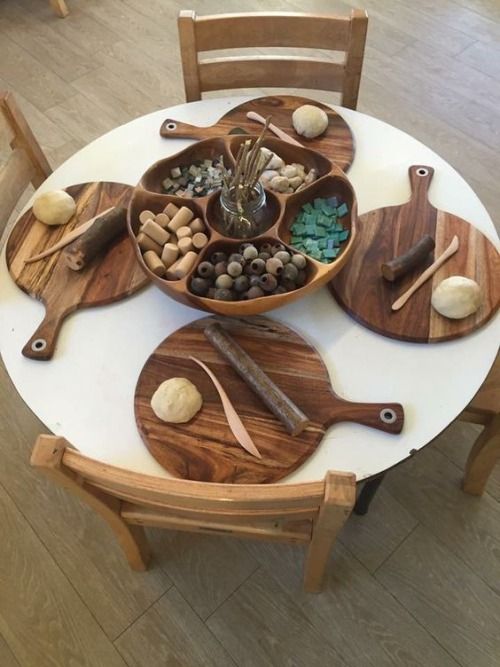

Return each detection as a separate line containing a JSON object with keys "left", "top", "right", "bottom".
{"left": 0, "top": 0, "right": 500, "bottom": 667}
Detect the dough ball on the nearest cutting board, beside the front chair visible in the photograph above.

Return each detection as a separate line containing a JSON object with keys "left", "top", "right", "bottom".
{"left": 151, "top": 378, "right": 203, "bottom": 424}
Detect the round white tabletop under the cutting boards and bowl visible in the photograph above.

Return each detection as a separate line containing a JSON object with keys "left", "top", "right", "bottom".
{"left": 0, "top": 97, "right": 500, "bottom": 483}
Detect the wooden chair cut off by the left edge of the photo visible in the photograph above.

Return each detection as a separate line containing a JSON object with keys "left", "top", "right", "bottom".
{"left": 0, "top": 91, "right": 52, "bottom": 235}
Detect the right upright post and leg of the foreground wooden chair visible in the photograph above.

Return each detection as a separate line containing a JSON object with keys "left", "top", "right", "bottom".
{"left": 304, "top": 472, "right": 356, "bottom": 593}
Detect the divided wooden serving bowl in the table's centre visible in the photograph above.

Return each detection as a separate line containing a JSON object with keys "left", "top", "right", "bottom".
{"left": 128, "top": 135, "right": 357, "bottom": 316}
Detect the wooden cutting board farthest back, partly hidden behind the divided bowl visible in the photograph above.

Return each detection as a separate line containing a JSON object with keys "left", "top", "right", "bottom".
{"left": 160, "top": 95, "right": 355, "bottom": 171}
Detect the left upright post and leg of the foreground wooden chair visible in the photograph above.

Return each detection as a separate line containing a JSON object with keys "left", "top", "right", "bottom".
{"left": 31, "top": 435, "right": 151, "bottom": 571}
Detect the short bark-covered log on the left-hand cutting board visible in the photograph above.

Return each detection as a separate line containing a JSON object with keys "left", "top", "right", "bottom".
{"left": 62, "top": 207, "right": 127, "bottom": 271}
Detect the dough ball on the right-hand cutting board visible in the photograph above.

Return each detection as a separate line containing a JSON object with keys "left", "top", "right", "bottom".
{"left": 431, "top": 276, "right": 482, "bottom": 320}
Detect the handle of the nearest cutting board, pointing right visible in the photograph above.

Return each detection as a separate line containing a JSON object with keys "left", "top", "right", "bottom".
{"left": 326, "top": 397, "right": 405, "bottom": 435}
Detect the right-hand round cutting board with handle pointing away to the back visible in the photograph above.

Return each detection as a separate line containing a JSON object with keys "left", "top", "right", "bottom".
{"left": 330, "top": 165, "right": 500, "bottom": 343}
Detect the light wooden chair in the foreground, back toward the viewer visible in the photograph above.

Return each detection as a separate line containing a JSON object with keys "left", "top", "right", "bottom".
{"left": 31, "top": 435, "right": 356, "bottom": 592}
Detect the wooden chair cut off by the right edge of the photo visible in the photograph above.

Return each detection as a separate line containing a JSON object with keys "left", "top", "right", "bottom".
{"left": 459, "top": 357, "right": 500, "bottom": 496}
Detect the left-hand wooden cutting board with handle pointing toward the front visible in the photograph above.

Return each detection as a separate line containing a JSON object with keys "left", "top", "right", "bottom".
{"left": 6, "top": 182, "right": 148, "bottom": 361}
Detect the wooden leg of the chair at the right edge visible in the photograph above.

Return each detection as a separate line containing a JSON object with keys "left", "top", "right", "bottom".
{"left": 462, "top": 414, "right": 500, "bottom": 496}
